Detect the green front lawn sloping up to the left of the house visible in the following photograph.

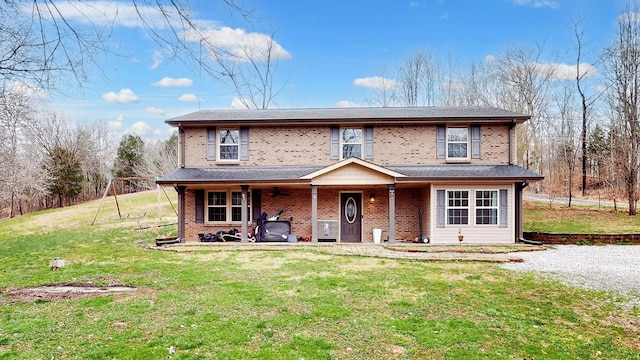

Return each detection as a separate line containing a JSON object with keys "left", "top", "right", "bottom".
{"left": 0, "top": 193, "right": 640, "bottom": 359}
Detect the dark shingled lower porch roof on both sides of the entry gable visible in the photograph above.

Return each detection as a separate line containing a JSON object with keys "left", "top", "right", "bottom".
{"left": 157, "top": 164, "right": 543, "bottom": 184}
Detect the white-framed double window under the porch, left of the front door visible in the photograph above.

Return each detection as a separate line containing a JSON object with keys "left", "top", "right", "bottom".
{"left": 207, "top": 191, "right": 251, "bottom": 223}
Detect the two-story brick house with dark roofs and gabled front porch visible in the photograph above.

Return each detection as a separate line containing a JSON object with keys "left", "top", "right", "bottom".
{"left": 157, "top": 107, "right": 543, "bottom": 244}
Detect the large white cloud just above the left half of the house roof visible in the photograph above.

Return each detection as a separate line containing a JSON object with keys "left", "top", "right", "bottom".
{"left": 184, "top": 26, "right": 291, "bottom": 62}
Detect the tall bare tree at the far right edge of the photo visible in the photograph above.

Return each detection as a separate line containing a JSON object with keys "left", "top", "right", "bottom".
{"left": 605, "top": 3, "right": 640, "bottom": 215}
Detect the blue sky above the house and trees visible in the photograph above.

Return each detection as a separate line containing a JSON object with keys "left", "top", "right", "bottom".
{"left": 31, "top": 0, "right": 624, "bottom": 139}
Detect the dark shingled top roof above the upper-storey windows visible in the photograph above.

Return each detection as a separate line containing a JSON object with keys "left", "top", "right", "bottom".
{"left": 166, "top": 106, "right": 530, "bottom": 125}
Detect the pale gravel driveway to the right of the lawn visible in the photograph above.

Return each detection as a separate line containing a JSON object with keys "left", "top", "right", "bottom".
{"left": 503, "top": 245, "right": 640, "bottom": 306}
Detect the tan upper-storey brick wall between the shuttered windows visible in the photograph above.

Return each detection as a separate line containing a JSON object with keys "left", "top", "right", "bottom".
{"left": 185, "top": 125, "right": 515, "bottom": 167}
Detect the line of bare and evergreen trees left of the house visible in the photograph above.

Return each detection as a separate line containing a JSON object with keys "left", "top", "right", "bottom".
{"left": 0, "top": 88, "right": 178, "bottom": 218}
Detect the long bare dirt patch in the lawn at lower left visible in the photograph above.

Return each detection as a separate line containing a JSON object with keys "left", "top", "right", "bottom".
{"left": 6, "top": 284, "right": 137, "bottom": 302}
